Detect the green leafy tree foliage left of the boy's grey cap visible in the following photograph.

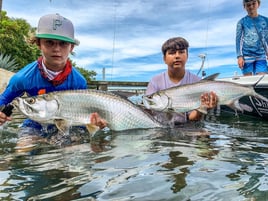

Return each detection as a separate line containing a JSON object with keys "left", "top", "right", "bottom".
{"left": 0, "top": 11, "right": 40, "bottom": 72}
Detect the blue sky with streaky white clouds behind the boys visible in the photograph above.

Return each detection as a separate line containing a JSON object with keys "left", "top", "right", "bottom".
{"left": 2, "top": 0, "right": 268, "bottom": 82}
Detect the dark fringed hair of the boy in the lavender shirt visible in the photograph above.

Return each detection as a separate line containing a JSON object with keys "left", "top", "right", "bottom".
{"left": 162, "top": 37, "right": 189, "bottom": 55}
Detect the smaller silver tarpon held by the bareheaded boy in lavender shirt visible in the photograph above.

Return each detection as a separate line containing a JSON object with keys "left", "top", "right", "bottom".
{"left": 143, "top": 80, "right": 268, "bottom": 114}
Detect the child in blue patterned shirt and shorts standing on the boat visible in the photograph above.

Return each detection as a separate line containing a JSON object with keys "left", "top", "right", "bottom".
{"left": 236, "top": 0, "right": 268, "bottom": 76}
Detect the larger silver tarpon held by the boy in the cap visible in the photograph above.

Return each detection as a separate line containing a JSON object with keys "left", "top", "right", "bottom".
{"left": 13, "top": 89, "right": 163, "bottom": 133}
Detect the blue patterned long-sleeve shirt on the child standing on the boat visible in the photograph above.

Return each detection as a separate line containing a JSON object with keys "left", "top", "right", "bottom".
{"left": 236, "top": 15, "right": 268, "bottom": 60}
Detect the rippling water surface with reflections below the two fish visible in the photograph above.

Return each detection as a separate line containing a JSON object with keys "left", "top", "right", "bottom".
{"left": 0, "top": 114, "right": 268, "bottom": 201}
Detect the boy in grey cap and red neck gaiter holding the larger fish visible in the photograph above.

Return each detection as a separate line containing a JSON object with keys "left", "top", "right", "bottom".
{"left": 0, "top": 14, "right": 106, "bottom": 137}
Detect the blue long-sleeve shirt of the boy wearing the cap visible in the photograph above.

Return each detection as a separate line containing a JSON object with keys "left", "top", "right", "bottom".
{"left": 0, "top": 61, "right": 87, "bottom": 129}
